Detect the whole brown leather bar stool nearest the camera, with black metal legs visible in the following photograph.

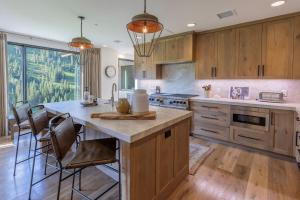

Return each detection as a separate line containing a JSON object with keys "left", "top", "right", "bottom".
{"left": 49, "top": 113, "right": 121, "bottom": 200}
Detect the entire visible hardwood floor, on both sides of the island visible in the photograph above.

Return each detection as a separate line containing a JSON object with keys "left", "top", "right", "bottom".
{"left": 0, "top": 135, "right": 300, "bottom": 200}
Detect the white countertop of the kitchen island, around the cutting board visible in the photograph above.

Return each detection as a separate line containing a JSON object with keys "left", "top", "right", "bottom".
{"left": 45, "top": 101, "right": 192, "bottom": 143}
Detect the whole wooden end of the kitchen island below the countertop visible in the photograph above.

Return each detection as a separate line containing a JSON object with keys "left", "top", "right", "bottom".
{"left": 127, "top": 119, "right": 191, "bottom": 200}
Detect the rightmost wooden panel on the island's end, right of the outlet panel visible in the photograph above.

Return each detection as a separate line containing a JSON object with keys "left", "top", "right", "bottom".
{"left": 174, "top": 119, "right": 191, "bottom": 176}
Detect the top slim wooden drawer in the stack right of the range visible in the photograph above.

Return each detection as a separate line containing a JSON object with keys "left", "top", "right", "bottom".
{"left": 191, "top": 101, "right": 230, "bottom": 114}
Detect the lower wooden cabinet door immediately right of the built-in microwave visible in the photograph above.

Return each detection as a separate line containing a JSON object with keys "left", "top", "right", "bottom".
{"left": 271, "top": 110, "right": 295, "bottom": 156}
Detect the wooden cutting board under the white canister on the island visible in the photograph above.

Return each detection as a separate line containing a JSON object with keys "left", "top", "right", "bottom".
{"left": 91, "top": 111, "right": 156, "bottom": 120}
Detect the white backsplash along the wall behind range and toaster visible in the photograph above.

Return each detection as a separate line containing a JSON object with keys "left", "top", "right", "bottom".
{"left": 137, "top": 63, "right": 300, "bottom": 103}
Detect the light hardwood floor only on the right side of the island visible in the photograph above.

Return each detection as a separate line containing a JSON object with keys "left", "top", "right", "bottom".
{"left": 169, "top": 140, "right": 300, "bottom": 200}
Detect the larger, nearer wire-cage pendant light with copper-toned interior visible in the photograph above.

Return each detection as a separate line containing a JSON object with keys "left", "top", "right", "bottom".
{"left": 127, "top": 0, "right": 164, "bottom": 57}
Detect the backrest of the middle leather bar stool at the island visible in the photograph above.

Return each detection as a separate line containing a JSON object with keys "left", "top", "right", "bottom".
{"left": 28, "top": 105, "right": 49, "bottom": 135}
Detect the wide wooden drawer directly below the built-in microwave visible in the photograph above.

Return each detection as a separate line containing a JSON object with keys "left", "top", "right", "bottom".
{"left": 230, "top": 126, "right": 273, "bottom": 150}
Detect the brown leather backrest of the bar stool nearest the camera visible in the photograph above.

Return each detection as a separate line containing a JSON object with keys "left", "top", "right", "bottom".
{"left": 50, "top": 116, "right": 76, "bottom": 162}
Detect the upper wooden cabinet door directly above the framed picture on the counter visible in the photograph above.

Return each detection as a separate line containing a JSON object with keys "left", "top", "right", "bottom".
{"left": 237, "top": 24, "right": 262, "bottom": 78}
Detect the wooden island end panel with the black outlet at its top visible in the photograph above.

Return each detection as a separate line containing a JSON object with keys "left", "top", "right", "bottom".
{"left": 156, "top": 129, "right": 174, "bottom": 192}
